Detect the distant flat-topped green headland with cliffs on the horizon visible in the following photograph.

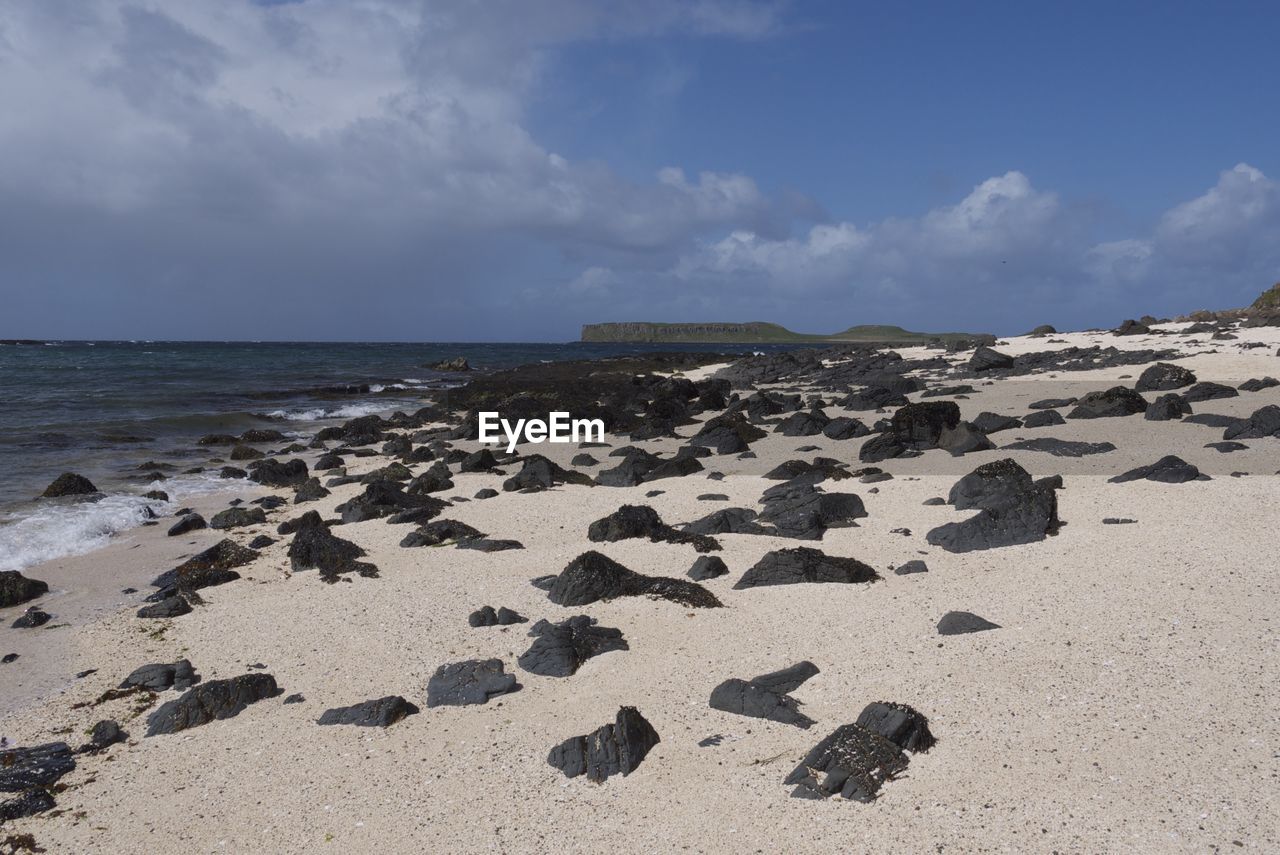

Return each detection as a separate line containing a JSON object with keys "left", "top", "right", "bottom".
{"left": 582, "top": 321, "right": 996, "bottom": 346}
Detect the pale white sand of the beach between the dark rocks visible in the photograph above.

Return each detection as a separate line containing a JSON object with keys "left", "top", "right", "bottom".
{"left": 0, "top": 323, "right": 1280, "bottom": 852}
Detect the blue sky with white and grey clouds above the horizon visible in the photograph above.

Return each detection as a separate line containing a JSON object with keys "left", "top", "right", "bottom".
{"left": 0, "top": 0, "right": 1280, "bottom": 342}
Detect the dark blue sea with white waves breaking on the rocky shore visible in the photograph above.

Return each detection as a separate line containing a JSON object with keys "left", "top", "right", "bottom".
{"left": 0, "top": 342, "right": 791, "bottom": 570}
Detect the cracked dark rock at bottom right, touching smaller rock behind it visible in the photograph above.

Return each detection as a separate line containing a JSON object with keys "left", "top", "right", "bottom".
{"left": 783, "top": 723, "right": 908, "bottom": 803}
